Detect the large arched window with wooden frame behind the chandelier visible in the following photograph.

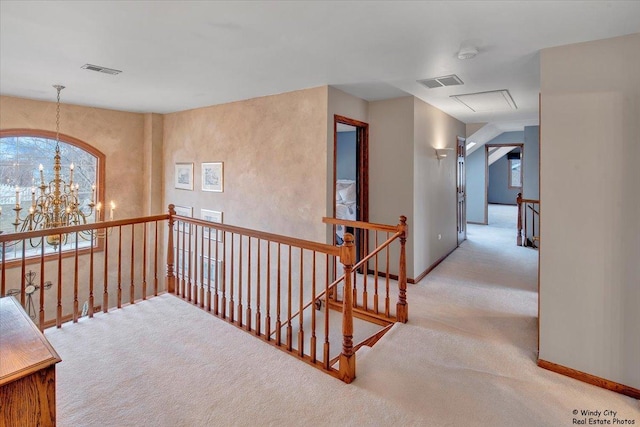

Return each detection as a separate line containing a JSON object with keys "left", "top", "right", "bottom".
{"left": 0, "top": 129, "right": 105, "bottom": 259}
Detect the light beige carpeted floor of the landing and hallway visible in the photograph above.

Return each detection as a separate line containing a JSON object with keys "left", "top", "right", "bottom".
{"left": 46, "top": 226, "right": 640, "bottom": 427}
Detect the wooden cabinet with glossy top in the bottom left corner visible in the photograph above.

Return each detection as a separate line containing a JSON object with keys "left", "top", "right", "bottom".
{"left": 0, "top": 297, "right": 60, "bottom": 427}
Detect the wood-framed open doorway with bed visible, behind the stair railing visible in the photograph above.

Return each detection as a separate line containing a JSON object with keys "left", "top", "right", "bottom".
{"left": 333, "top": 115, "right": 369, "bottom": 260}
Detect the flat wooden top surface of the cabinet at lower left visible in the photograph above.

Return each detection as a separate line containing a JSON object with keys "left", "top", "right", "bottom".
{"left": 0, "top": 297, "right": 61, "bottom": 386}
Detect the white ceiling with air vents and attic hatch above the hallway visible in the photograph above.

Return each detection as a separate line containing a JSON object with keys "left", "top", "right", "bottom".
{"left": 0, "top": 0, "right": 640, "bottom": 131}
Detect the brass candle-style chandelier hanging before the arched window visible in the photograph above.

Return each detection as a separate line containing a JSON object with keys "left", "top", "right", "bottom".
{"left": 0, "top": 85, "right": 115, "bottom": 248}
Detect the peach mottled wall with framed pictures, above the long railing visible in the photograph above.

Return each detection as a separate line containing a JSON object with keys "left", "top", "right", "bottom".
{"left": 163, "top": 86, "right": 328, "bottom": 242}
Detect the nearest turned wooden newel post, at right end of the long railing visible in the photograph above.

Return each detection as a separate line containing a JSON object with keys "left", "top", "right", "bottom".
{"left": 340, "top": 233, "right": 356, "bottom": 384}
